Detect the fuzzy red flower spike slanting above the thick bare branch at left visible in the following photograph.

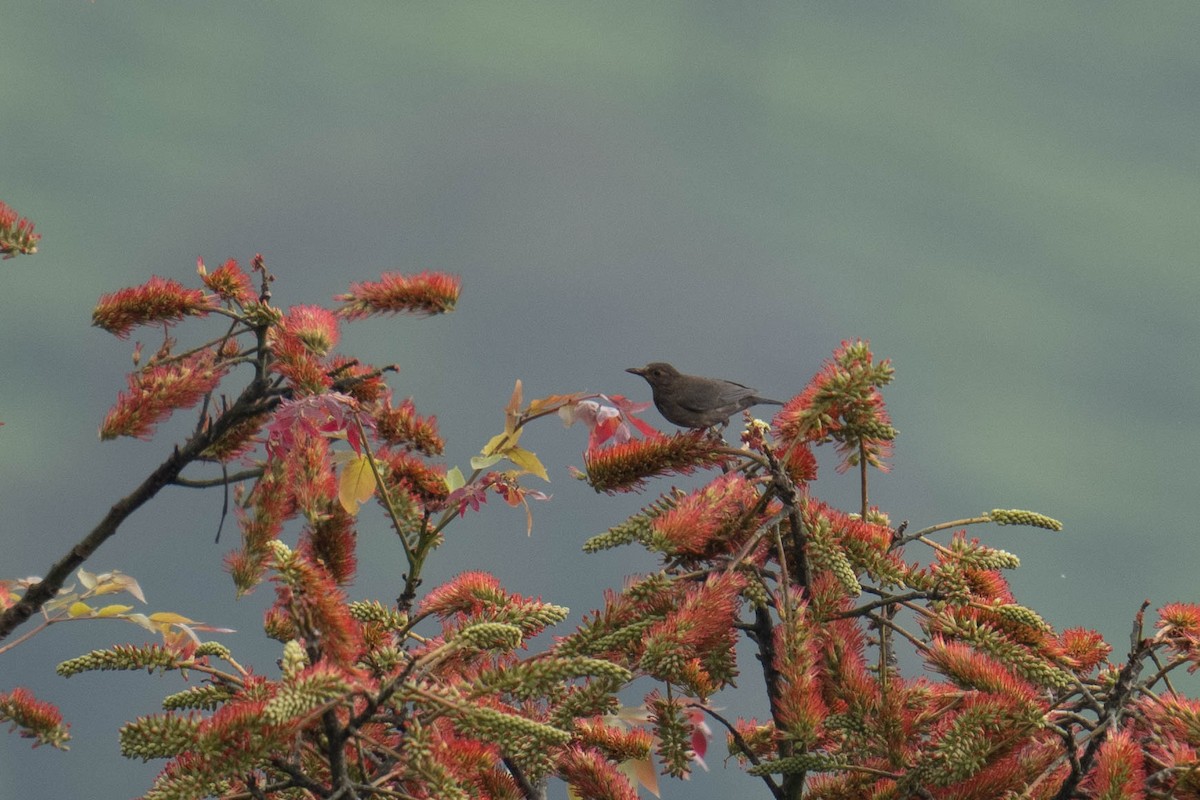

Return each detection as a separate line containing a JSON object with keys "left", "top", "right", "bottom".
{"left": 100, "top": 350, "right": 226, "bottom": 439}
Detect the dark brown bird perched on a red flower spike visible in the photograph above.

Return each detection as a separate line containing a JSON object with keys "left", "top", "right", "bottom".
{"left": 625, "top": 361, "right": 782, "bottom": 428}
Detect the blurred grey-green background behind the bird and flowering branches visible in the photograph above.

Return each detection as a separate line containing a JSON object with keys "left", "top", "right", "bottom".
{"left": 0, "top": 0, "right": 1200, "bottom": 800}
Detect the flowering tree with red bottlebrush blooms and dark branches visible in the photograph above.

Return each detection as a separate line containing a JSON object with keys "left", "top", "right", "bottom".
{"left": 0, "top": 201, "right": 1200, "bottom": 800}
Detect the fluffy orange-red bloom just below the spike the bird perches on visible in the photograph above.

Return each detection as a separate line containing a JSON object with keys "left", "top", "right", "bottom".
{"left": 652, "top": 473, "right": 758, "bottom": 555}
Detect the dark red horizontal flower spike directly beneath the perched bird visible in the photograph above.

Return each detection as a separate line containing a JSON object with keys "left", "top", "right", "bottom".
{"left": 583, "top": 431, "right": 728, "bottom": 494}
